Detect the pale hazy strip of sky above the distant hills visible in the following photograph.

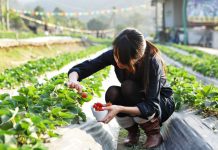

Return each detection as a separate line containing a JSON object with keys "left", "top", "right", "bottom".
{"left": 10, "top": 0, "right": 150, "bottom": 12}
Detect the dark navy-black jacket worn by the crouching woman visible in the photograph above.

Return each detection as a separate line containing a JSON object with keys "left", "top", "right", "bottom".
{"left": 68, "top": 50, "right": 172, "bottom": 118}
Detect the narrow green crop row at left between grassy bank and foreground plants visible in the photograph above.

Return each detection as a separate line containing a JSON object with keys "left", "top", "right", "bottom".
{"left": 0, "top": 45, "right": 106, "bottom": 89}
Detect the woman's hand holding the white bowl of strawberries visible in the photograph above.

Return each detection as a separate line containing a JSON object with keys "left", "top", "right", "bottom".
{"left": 101, "top": 105, "right": 121, "bottom": 123}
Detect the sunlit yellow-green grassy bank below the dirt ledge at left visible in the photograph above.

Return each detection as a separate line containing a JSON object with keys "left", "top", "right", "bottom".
{"left": 0, "top": 43, "right": 84, "bottom": 72}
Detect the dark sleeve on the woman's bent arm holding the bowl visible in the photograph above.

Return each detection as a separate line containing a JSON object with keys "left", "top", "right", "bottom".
{"left": 137, "top": 58, "right": 163, "bottom": 119}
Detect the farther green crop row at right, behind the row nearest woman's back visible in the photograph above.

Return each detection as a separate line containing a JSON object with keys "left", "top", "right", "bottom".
{"left": 158, "top": 45, "right": 218, "bottom": 78}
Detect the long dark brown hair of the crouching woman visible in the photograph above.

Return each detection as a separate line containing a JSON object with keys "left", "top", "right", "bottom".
{"left": 113, "top": 28, "right": 165, "bottom": 93}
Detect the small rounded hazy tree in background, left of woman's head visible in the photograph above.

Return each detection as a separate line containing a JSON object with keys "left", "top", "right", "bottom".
{"left": 87, "top": 18, "right": 107, "bottom": 30}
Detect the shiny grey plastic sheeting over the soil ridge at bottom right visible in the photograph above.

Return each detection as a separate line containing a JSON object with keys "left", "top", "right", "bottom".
{"left": 160, "top": 111, "right": 218, "bottom": 150}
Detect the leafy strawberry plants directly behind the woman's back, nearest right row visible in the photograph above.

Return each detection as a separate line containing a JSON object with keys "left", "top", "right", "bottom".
{"left": 167, "top": 66, "right": 218, "bottom": 115}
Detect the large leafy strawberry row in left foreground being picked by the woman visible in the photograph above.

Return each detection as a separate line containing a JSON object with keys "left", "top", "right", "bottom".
{"left": 0, "top": 68, "right": 110, "bottom": 149}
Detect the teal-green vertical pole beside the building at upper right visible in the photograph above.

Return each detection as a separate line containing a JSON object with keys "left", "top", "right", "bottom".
{"left": 182, "top": 0, "right": 188, "bottom": 45}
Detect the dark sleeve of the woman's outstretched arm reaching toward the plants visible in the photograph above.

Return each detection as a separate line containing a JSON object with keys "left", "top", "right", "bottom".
{"left": 68, "top": 50, "right": 114, "bottom": 81}
